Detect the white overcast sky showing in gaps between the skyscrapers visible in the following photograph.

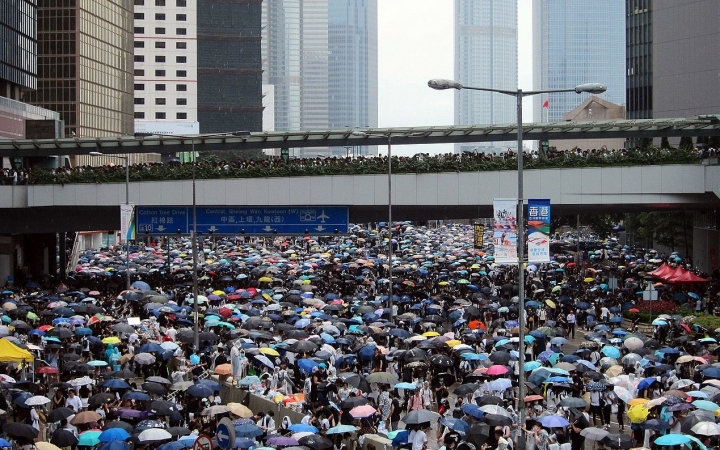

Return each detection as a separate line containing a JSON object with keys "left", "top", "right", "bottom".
{"left": 378, "top": 0, "right": 532, "bottom": 155}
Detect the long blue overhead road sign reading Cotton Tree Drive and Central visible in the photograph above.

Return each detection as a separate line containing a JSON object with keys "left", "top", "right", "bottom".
{"left": 135, "top": 206, "right": 348, "bottom": 236}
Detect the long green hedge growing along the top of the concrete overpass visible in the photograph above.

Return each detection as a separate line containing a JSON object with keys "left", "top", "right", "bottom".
{"left": 29, "top": 148, "right": 700, "bottom": 184}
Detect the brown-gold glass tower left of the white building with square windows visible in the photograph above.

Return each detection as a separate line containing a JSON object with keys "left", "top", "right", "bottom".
{"left": 27, "top": 0, "right": 140, "bottom": 165}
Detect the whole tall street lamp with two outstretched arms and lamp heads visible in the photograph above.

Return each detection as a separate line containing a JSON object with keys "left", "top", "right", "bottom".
{"left": 428, "top": 79, "right": 607, "bottom": 449}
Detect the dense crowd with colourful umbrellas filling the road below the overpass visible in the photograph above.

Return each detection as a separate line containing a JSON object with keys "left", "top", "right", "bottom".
{"left": 0, "top": 223, "right": 720, "bottom": 450}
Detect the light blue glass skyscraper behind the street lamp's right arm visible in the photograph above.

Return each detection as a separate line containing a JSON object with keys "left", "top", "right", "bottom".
{"left": 533, "top": 0, "right": 625, "bottom": 122}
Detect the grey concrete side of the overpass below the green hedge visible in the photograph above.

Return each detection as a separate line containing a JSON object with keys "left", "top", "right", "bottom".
{"left": 0, "top": 163, "right": 720, "bottom": 234}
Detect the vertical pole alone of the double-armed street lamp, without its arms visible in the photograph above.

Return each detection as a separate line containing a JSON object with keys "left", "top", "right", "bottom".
{"left": 515, "top": 89, "right": 527, "bottom": 450}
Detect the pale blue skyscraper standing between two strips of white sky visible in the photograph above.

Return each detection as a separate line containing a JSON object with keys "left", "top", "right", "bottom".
{"left": 455, "top": 0, "right": 518, "bottom": 153}
